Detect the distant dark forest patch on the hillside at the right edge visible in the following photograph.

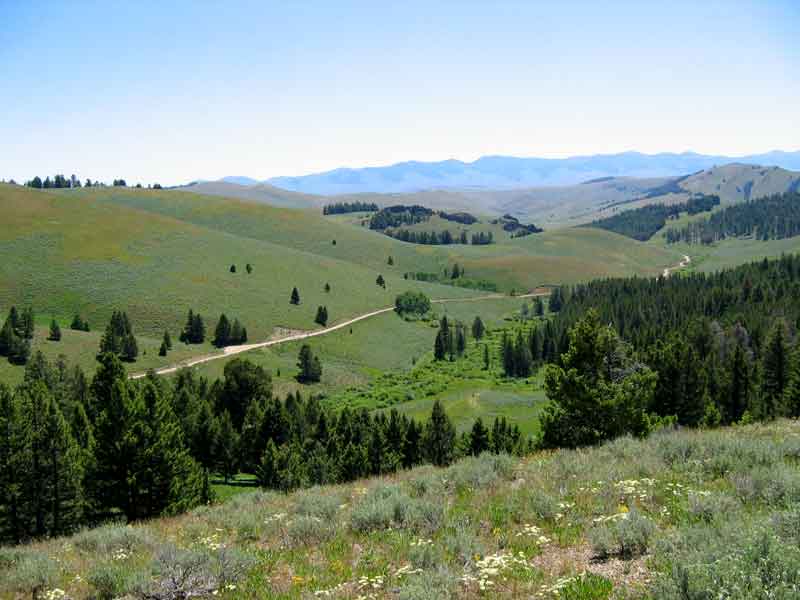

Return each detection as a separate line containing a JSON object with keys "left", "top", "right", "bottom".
{"left": 664, "top": 191, "right": 800, "bottom": 244}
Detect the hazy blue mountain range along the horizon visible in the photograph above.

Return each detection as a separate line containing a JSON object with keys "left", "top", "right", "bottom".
{"left": 205, "top": 151, "right": 800, "bottom": 196}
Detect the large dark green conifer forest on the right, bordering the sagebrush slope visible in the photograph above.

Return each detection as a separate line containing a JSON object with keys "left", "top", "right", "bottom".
{"left": 528, "top": 256, "right": 800, "bottom": 445}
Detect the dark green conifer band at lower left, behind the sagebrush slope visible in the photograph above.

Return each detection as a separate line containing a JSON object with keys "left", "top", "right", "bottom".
{"left": 0, "top": 352, "right": 526, "bottom": 543}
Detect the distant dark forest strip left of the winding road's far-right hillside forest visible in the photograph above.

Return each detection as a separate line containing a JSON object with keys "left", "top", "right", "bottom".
{"left": 585, "top": 196, "right": 719, "bottom": 242}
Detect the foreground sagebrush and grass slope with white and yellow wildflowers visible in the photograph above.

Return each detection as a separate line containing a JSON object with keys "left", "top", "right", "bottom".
{"left": 0, "top": 420, "right": 800, "bottom": 600}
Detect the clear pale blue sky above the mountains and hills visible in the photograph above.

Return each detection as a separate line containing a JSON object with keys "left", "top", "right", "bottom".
{"left": 0, "top": 0, "right": 800, "bottom": 185}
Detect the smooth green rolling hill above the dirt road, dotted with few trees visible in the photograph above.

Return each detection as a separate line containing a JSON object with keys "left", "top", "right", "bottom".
{"left": 0, "top": 180, "right": 678, "bottom": 382}
